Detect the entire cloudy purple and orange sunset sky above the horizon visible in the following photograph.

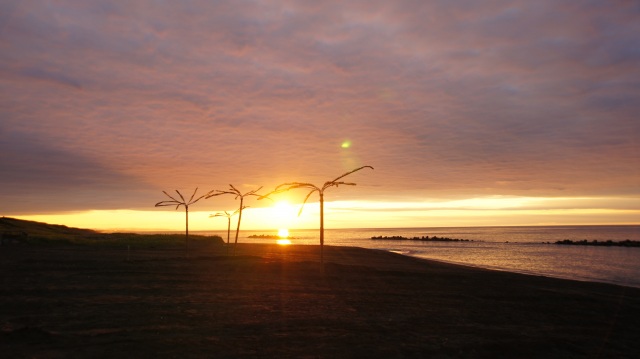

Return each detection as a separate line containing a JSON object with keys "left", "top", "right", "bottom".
{"left": 0, "top": 0, "right": 640, "bottom": 230}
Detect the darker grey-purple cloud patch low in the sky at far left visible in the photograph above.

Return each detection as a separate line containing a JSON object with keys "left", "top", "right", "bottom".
{"left": 0, "top": 131, "right": 154, "bottom": 214}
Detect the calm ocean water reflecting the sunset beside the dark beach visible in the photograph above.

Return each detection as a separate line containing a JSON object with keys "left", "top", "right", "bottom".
{"left": 194, "top": 225, "right": 640, "bottom": 288}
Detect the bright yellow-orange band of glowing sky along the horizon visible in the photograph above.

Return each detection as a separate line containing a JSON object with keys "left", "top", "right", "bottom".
{"left": 17, "top": 197, "right": 640, "bottom": 235}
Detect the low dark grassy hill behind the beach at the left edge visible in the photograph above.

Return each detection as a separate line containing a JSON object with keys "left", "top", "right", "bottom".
{"left": 0, "top": 217, "right": 224, "bottom": 248}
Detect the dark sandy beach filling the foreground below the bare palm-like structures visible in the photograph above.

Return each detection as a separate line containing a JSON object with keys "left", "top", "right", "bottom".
{"left": 0, "top": 244, "right": 640, "bottom": 358}
